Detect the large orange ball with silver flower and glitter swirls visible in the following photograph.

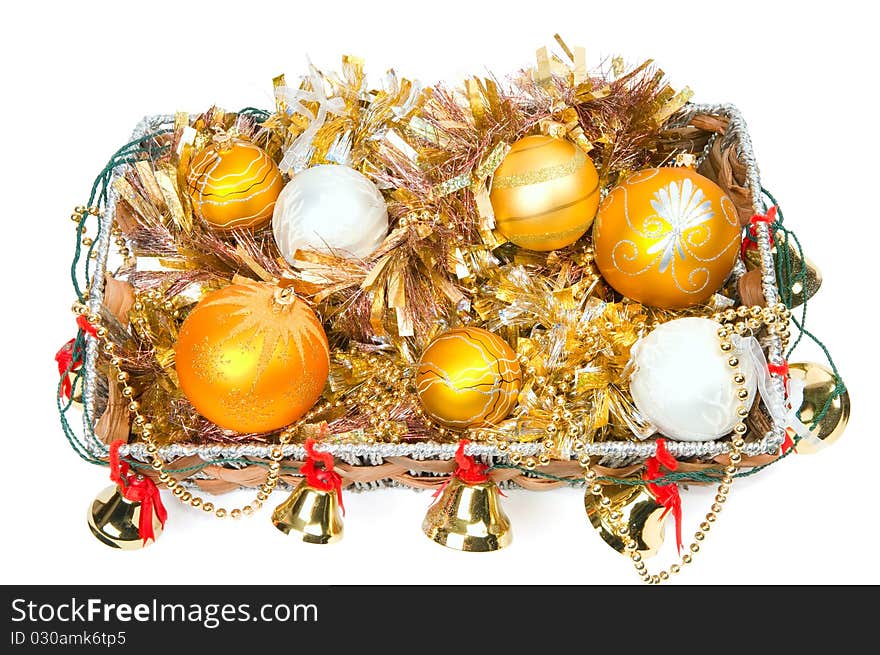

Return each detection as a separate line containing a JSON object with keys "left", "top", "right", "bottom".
{"left": 593, "top": 168, "right": 741, "bottom": 309}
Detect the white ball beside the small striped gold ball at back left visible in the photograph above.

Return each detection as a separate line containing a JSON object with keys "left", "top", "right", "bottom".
{"left": 272, "top": 164, "right": 388, "bottom": 264}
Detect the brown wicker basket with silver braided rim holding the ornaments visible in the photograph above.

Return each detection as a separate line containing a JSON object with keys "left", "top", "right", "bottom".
{"left": 65, "top": 104, "right": 785, "bottom": 493}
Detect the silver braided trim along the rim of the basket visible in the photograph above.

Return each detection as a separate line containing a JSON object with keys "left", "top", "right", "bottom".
{"left": 83, "top": 104, "right": 785, "bottom": 466}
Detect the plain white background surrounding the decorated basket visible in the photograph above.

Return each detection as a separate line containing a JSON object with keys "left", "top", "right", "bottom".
{"left": 0, "top": 0, "right": 880, "bottom": 584}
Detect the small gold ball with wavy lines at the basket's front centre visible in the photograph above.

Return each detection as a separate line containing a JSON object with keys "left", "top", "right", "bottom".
{"left": 416, "top": 327, "right": 522, "bottom": 429}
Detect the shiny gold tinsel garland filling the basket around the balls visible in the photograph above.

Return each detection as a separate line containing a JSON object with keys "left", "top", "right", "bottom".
{"left": 99, "top": 41, "right": 730, "bottom": 448}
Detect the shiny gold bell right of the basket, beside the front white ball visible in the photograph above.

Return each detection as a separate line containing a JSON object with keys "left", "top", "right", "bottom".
{"left": 788, "top": 362, "right": 850, "bottom": 455}
